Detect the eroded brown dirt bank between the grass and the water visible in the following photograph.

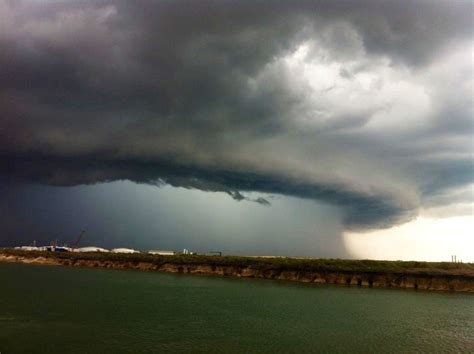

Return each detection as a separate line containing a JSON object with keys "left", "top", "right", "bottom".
{"left": 0, "top": 252, "right": 474, "bottom": 293}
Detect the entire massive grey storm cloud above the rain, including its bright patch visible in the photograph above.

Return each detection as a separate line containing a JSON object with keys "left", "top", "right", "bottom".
{"left": 0, "top": 1, "right": 473, "bottom": 228}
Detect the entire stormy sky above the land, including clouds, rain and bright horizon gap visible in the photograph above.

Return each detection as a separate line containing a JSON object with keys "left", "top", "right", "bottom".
{"left": 0, "top": 0, "right": 474, "bottom": 261}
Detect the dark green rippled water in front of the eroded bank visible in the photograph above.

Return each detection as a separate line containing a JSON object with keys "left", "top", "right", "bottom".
{"left": 0, "top": 263, "right": 474, "bottom": 354}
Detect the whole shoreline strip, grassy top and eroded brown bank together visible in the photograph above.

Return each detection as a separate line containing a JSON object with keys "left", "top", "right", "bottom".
{"left": 0, "top": 249, "right": 474, "bottom": 293}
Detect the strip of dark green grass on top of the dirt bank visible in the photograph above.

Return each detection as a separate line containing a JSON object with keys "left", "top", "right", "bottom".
{"left": 0, "top": 248, "right": 474, "bottom": 277}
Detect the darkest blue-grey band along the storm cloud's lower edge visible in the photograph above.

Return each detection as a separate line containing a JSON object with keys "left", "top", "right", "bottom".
{"left": 0, "top": 158, "right": 413, "bottom": 228}
